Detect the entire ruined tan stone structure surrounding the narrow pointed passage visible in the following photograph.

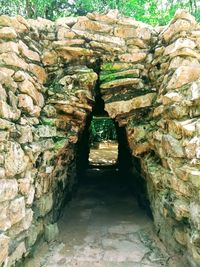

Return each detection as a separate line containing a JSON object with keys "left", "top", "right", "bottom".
{"left": 0, "top": 10, "right": 200, "bottom": 266}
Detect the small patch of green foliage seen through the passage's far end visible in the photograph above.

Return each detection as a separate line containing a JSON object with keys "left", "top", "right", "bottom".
{"left": 89, "top": 117, "right": 117, "bottom": 144}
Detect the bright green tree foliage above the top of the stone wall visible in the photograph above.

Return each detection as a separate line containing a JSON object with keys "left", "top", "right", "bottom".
{"left": 0, "top": 0, "right": 200, "bottom": 25}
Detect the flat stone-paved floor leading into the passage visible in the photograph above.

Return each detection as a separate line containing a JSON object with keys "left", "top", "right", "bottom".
{"left": 25, "top": 170, "right": 177, "bottom": 267}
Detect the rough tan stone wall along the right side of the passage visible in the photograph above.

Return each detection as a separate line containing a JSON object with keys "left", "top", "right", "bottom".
{"left": 127, "top": 11, "right": 200, "bottom": 266}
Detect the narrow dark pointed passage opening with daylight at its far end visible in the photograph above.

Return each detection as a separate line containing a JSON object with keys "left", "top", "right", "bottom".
{"left": 77, "top": 74, "right": 151, "bottom": 216}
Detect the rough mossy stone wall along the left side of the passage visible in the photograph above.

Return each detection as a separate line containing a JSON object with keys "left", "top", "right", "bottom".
{"left": 0, "top": 16, "right": 97, "bottom": 266}
